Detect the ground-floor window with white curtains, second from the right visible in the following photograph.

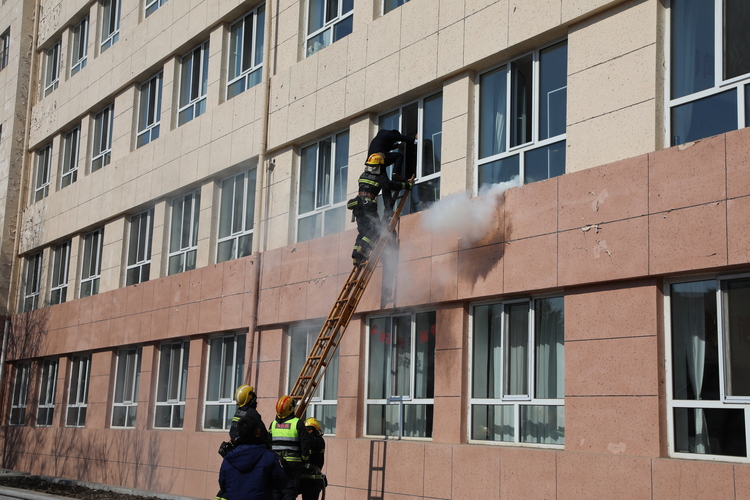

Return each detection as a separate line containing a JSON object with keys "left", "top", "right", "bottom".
{"left": 469, "top": 297, "right": 565, "bottom": 445}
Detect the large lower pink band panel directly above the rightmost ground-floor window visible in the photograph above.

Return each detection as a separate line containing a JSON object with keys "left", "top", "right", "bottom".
{"left": 649, "top": 202, "right": 727, "bottom": 275}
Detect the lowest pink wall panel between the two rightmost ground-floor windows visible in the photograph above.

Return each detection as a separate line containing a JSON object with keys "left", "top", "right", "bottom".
{"left": 560, "top": 396, "right": 660, "bottom": 458}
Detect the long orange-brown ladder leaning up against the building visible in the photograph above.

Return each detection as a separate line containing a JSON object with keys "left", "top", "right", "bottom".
{"left": 289, "top": 184, "right": 410, "bottom": 418}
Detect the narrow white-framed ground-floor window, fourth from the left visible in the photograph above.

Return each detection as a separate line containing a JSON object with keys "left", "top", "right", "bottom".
{"left": 112, "top": 347, "right": 141, "bottom": 427}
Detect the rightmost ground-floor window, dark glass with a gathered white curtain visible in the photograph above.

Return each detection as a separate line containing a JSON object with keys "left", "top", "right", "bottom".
{"left": 666, "top": 275, "right": 750, "bottom": 461}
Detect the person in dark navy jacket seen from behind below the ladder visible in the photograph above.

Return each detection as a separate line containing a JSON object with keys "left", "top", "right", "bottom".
{"left": 217, "top": 415, "right": 287, "bottom": 500}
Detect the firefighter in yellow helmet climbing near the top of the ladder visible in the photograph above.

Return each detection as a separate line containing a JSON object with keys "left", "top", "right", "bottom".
{"left": 347, "top": 153, "right": 413, "bottom": 266}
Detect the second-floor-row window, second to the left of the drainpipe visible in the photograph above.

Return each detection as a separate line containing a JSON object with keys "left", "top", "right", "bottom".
{"left": 168, "top": 190, "right": 201, "bottom": 276}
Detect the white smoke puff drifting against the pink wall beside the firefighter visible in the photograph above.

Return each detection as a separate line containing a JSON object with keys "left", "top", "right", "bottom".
{"left": 422, "top": 176, "right": 520, "bottom": 242}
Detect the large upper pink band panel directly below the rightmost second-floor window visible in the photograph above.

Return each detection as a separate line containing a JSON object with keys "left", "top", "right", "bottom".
{"left": 649, "top": 135, "right": 726, "bottom": 214}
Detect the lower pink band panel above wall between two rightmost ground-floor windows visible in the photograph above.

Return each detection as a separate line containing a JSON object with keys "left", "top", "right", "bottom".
{"left": 558, "top": 217, "right": 648, "bottom": 286}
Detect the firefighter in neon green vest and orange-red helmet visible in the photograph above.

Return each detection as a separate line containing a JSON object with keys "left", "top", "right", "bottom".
{"left": 269, "top": 396, "right": 310, "bottom": 500}
